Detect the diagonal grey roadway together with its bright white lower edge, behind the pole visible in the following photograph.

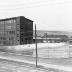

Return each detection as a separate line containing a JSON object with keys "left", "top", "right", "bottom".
{"left": 0, "top": 53, "right": 72, "bottom": 72}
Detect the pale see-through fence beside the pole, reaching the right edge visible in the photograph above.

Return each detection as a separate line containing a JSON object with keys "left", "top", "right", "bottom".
{"left": 33, "top": 45, "right": 72, "bottom": 58}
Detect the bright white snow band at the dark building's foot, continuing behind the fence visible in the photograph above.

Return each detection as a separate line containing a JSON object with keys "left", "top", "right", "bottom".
{"left": 7, "top": 43, "right": 66, "bottom": 50}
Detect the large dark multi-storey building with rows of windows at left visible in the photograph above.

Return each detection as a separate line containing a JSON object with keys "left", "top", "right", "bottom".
{"left": 0, "top": 16, "right": 33, "bottom": 46}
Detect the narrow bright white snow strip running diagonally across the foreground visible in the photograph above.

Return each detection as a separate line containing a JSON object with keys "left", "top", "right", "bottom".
{"left": 0, "top": 56, "right": 72, "bottom": 72}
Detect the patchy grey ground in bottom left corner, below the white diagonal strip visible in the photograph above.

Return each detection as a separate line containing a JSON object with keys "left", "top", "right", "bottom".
{"left": 0, "top": 59, "right": 46, "bottom": 72}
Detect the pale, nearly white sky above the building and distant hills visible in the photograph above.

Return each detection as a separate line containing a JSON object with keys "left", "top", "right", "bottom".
{"left": 0, "top": 0, "right": 72, "bottom": 31}
